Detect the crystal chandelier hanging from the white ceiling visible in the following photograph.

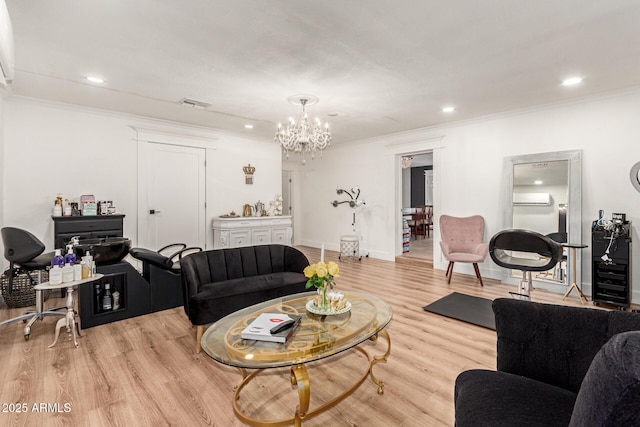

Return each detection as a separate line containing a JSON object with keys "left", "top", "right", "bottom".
{"left": 274, "top": 95, "right": 331, "bottom": 164}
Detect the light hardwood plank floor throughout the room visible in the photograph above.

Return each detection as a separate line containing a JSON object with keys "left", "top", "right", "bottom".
{"left": 0, "top": 248, "right": 624, "bottom": 427}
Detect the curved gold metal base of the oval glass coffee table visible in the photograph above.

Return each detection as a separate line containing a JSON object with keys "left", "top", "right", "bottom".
{"left": 233, "top": 330, "right": 391, "bottom": 427}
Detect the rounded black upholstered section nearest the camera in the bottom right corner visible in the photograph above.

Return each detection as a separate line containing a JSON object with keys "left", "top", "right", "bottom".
{"left": 569, "top": 331, "right": 640, "bottom": 427}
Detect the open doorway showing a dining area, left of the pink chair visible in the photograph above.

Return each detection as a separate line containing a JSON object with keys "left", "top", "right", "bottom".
{"left": 396, "top": 150, "right": 434, "bottom": 266}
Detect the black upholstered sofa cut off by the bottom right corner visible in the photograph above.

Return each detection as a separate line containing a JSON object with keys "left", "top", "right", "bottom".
{"left": 454, "top": 298, "right": 640, "bottom": 427}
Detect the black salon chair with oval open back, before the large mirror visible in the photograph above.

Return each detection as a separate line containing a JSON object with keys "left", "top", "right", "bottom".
{"left": 489, "top": 229, "right": 562, "bottom": 299}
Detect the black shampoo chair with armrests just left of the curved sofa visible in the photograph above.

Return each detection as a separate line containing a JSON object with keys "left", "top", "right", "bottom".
{"left": 129, "top": 243, "right": 202, "bottom": 312}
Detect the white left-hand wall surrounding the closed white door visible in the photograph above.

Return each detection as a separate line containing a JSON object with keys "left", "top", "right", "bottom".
{"left": 2, "top": 98, "right": 281, "bottom": 250}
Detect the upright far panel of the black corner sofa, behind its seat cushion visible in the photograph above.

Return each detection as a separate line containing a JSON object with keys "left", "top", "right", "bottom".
{"left": 493, "top": 298, "right": 640, "bottom": 392}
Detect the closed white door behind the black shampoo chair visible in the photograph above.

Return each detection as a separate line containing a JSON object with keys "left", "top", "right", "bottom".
{"left": 141, "top": 143, "right": 206, "bottom": 250}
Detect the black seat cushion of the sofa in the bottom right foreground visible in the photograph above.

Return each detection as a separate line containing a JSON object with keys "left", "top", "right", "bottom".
{"left": 455, "top": 369, "right": 576, "bottom": 427}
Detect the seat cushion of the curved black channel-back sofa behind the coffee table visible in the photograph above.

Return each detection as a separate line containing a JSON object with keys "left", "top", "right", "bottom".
{"left": 189, "top": 271, "right": 307, "bottom": 325}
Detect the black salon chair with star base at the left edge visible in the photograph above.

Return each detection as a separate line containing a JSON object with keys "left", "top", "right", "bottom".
{"left": 0, "top": 227, "right": 66, "bottom": 340}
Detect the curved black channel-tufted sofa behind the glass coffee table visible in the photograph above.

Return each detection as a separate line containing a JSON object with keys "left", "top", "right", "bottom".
{"left": 180, "top": 244, "right": 309, "bottom": 353}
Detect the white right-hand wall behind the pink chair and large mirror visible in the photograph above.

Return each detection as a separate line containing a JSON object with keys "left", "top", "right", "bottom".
{"left": 297, "top": 90, "right": 640, "bottom": 301}
